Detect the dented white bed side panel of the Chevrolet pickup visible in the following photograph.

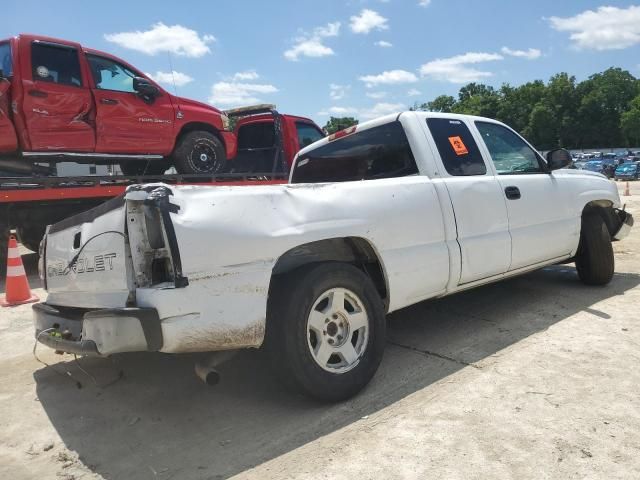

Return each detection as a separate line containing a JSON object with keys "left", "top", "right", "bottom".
{"left": 132, "top": 176, "right": 449, "bottom": 352}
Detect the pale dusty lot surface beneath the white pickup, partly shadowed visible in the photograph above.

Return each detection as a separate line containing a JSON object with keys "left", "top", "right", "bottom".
{"left": 0, "top": 182, "right": 640, "bottom": 480}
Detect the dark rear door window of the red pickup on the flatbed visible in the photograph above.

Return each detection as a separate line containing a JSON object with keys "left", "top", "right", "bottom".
{"left": 31, "top": 42, "right": 82, "bottom": 87}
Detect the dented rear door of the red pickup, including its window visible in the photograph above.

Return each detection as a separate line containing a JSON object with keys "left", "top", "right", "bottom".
{"left": 20, "top": 40, "right": 95, "bottom": 152}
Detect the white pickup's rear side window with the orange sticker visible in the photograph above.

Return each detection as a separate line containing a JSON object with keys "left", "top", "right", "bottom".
{"left": 427, "top": 118, "right": 487, "bottom": 177}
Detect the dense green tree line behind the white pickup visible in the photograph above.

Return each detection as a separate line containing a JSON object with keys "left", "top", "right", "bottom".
{"left": 325, "top": 68, "right": 640, "bottom": 150}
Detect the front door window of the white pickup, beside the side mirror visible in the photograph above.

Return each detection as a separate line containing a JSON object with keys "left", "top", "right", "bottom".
{"left": 476, "top": 122, "right": 545, "bottom": 175}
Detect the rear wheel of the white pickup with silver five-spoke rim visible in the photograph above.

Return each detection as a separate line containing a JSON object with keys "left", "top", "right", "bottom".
{"left": 266, "top": 262, "right": 386, "bottom": 402}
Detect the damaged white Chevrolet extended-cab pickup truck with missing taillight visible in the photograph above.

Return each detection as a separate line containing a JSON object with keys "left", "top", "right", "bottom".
{"left": 34, "top": 112, "right": 633, "bottom": 401}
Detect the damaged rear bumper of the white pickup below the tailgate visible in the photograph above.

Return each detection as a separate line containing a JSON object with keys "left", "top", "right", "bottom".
{"left": 33, "top": 303, "right": 163, "bottom": 356}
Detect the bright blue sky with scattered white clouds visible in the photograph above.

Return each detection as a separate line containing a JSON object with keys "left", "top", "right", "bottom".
{"left": 5, "top": 0, "right": 640, "bottom": 124}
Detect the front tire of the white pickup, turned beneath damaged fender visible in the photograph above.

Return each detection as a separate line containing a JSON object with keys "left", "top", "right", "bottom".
{"left": 576, "top": 214, "right": 615, "bottom": 285}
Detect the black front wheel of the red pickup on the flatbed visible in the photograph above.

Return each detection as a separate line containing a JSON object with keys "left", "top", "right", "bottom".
{"left": 173, "top": 131, "right": 227, "bottom": 174}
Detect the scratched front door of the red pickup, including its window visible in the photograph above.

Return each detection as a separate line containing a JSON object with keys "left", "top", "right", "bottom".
{"left": 87, "top": 53, "right": 175, "bottom": 155}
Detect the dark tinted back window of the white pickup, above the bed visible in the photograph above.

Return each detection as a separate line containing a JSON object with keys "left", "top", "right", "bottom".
{"left": 291, "top": 122, "right": 418, "bottom": 183}
